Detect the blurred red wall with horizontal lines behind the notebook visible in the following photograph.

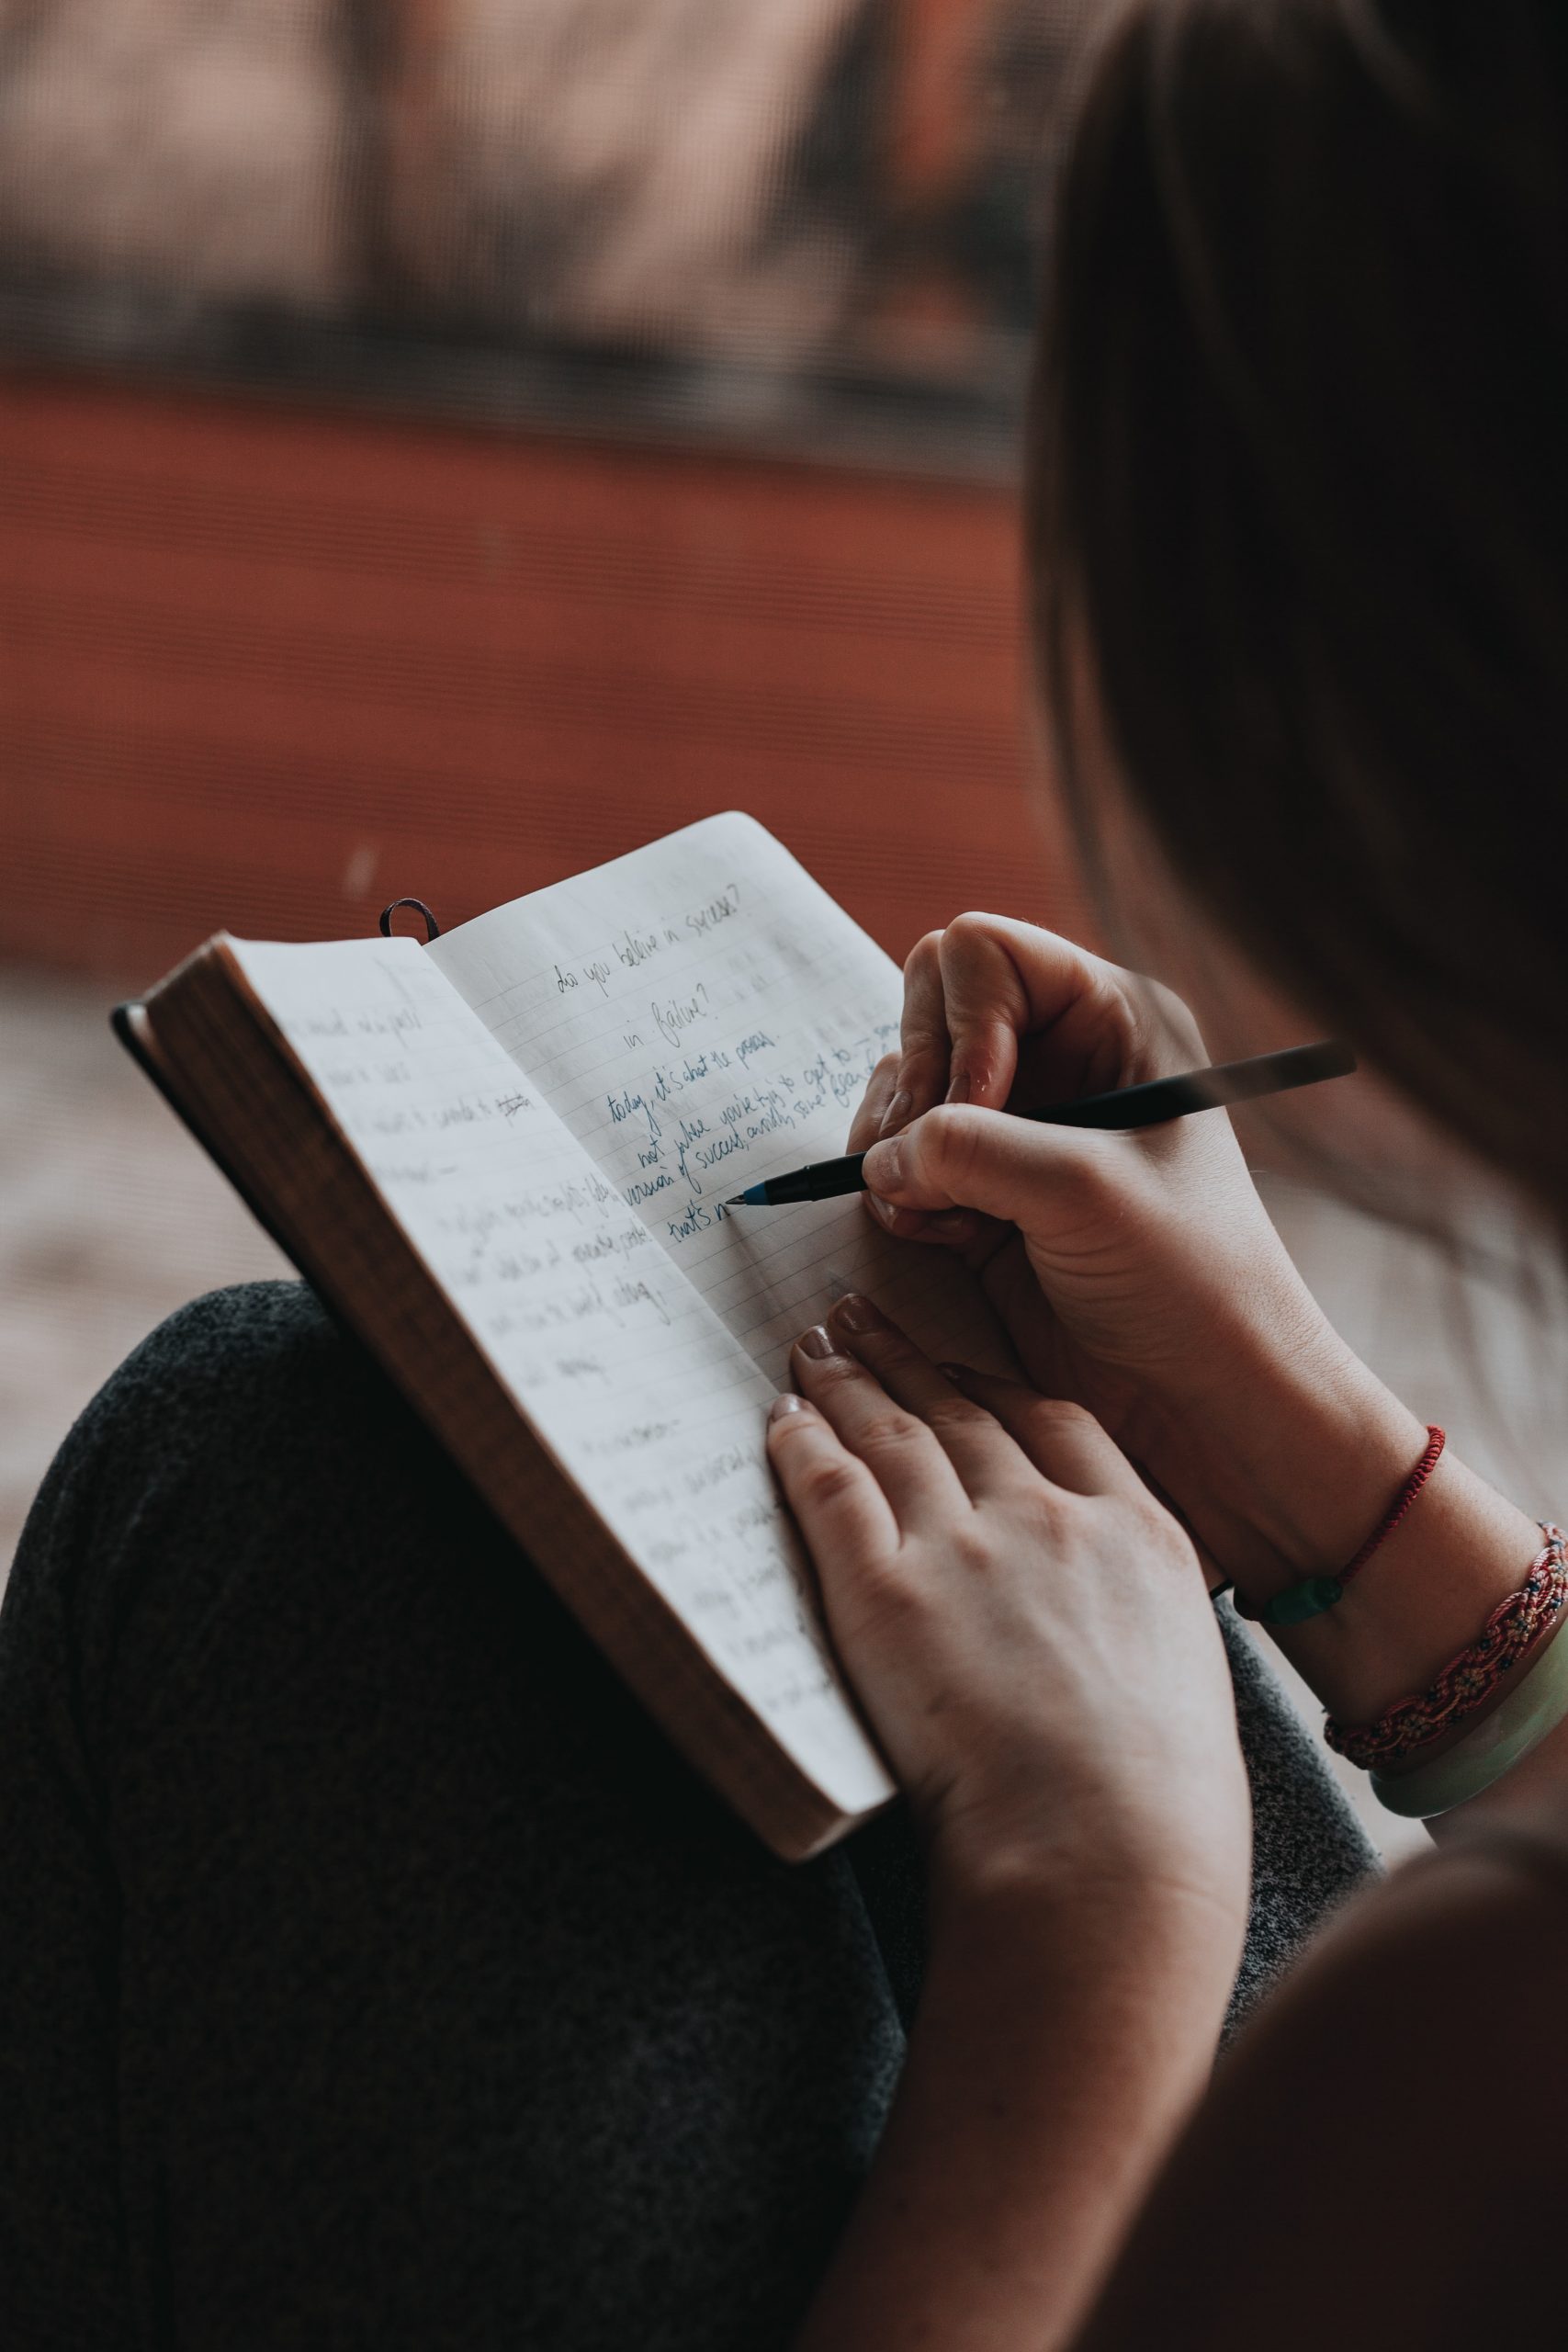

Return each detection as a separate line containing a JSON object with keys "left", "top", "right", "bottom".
{"left": 0, "top": 377, "right": 1079, "bottom": 978}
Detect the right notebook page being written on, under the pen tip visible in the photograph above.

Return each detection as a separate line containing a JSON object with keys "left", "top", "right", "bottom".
{"left": 425, "top": 814, "right": 1013, "bottom": 1385}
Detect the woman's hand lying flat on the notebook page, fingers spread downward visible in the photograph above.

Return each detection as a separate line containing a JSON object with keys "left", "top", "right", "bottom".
{"left": 769, "top": 1298, "right": 1251, "bottom": 1928}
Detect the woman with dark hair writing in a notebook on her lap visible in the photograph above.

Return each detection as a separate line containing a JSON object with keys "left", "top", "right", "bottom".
{"left": 0, "top": 0, "right": 1568, "bottom": 2352}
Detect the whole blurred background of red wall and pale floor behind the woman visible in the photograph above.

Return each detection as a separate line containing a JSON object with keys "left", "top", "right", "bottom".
{"left": 0, "top": 0, "right": 1568, "bottom": 1844}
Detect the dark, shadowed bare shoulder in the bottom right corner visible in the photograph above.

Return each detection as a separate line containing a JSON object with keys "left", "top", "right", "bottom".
{"left": 1084, "top": 1820, "right": 1568, "bottom": 2352}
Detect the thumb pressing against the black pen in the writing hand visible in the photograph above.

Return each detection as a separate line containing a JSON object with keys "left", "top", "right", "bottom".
{"left": 865, "top": 1103, "right": 1110, "bottom": 1230}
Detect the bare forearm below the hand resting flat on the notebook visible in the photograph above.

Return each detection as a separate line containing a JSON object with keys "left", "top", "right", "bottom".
{"left": 799, "top": 1879, "right": 1239, "bottom": 2352}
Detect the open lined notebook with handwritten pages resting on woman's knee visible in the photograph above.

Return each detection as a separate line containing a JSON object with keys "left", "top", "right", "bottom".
{"left": 115, "top": 814, "right": 1006, "bottom": 1856}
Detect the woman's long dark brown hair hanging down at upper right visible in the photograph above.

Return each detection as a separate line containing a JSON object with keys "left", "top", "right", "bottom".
{"left": 1030, "top": 0, "right": 1568, "bottom": 1204}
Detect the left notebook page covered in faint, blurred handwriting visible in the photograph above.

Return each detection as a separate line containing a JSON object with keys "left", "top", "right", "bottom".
{"left": 231, "top": 938, "right": 888, "bottom": 1814}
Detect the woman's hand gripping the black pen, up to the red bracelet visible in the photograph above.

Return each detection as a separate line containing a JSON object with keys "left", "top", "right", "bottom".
{"left": 849, "top": 915, "right": 1422, "bottom": 1588}
